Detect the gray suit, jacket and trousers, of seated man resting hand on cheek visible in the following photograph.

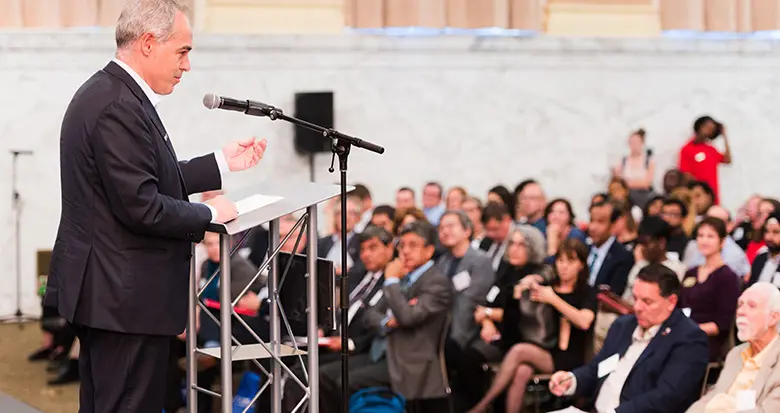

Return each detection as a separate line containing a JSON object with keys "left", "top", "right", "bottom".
{"left": 320, "top": 261, "right": 453, "bottom": 412}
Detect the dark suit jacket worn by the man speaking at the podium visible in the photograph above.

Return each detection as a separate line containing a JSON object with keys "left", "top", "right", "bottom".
{"left": 44, "top": 62, "right": 222, "bottom": 335}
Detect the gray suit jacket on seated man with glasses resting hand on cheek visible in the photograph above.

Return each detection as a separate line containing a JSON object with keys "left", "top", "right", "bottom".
{"left": 364, "top": 266, "right": 453, "bottom": 400}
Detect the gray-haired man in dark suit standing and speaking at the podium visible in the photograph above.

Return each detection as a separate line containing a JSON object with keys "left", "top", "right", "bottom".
{"left": 44, "top": 0, "right": 266, "bottom": 413}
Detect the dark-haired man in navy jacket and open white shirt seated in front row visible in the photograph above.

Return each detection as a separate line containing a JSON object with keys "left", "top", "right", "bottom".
{"left": 550, "top": 264, "right": 707, "bottom": 413}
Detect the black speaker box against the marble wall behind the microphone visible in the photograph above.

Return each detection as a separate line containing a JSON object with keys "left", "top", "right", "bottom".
{"left": 293, "top": 92, "right": 333, "bottom": 154}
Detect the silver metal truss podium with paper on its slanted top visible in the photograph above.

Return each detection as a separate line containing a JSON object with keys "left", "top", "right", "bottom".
{"left": 187, "top": 182, "right": 346, "bottom": 413}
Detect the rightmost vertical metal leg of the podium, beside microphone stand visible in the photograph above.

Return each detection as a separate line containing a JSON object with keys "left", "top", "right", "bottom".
{"left": 306, "top": 205, "right": 320, "bottom": 413}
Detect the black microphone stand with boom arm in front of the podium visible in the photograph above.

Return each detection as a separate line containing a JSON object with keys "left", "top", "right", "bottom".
{"left": 262, "top": 104, "right": 385, "bottom": 413}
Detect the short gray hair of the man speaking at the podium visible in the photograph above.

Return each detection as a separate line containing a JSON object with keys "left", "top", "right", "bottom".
{"left": 116, "top": 0, "right": 188, "bottom": 49}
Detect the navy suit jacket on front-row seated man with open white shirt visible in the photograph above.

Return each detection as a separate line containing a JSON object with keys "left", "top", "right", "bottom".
{"left": 573, "top": 309, "right": 709, "bottom": 413}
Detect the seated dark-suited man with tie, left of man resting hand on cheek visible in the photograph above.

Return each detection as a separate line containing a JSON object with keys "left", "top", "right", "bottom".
{"left": 282, "top": 225, "right": 393, "bottom": 412}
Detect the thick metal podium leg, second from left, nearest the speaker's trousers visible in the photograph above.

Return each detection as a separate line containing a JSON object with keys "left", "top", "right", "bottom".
{"left": 219, "top": 234, "right": 233, "bottom": 412}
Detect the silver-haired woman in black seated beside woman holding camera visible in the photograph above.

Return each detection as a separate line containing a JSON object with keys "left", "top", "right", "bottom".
{"left": 460, "top": 224, "right": 555, "bottom": 407}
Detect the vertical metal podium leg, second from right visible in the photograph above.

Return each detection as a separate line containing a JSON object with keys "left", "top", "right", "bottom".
{"left": 268, "top": 219, "right": 282, "bottom": 413}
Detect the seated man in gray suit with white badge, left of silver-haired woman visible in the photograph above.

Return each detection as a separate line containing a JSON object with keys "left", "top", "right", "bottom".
{"left": 436, "top": 211, "right": 496, "bottom": 366}
